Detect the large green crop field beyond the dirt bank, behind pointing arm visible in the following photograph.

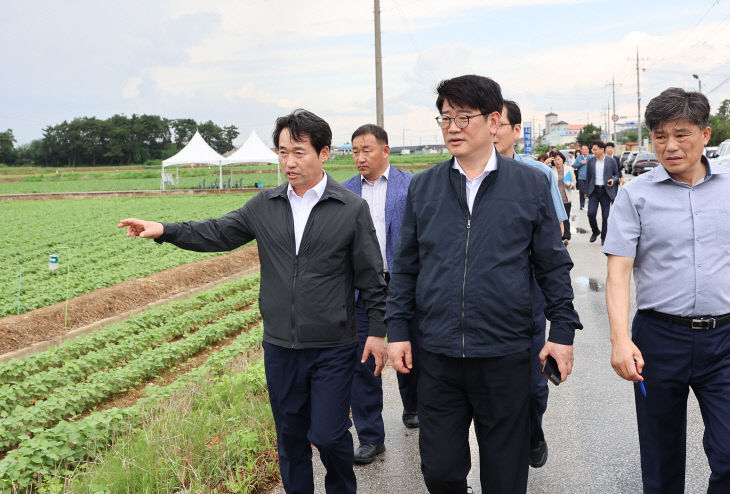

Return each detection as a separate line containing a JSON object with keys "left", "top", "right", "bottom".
{"left": 0, "top": 194, "right": 258, "bottom": 317}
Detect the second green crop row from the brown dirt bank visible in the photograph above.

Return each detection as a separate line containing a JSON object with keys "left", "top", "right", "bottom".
{"left": 0, "top": 288, "right": 258, "bottom": 418}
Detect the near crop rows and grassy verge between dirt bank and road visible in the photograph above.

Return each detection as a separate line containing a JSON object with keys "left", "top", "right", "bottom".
{"left": 0, "top": 276, "right": 277, "bottom": 493}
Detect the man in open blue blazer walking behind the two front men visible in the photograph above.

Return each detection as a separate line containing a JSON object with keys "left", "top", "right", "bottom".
{"left": 342, "top": 124, "right": 418, "bottom": 464}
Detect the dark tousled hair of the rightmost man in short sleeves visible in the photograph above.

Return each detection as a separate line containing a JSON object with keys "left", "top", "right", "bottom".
{"left": 644, "top": 87, "right": 710, "bottom": 131}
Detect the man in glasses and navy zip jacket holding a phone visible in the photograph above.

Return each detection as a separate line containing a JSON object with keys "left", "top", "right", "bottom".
{"left": 386, "top": 75, "right": 582, "bottom": 494}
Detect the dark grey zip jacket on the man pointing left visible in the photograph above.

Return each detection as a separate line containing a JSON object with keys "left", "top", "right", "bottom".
{"left": 157, "top": 176, "right": 385, "bottom": 348}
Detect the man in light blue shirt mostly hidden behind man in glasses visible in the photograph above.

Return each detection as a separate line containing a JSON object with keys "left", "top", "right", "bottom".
{"left": 494, "top": 100, "right": 568, "bottom": 468}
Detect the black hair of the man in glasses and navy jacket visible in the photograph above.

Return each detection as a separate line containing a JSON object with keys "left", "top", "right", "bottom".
{"left": 436, "top": 75, "right": 503, "bottom": 115}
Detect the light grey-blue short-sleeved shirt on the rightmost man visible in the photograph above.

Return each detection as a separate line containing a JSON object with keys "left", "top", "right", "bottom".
{"left": 603, "top": 156, "right": 730, "bottom": 317}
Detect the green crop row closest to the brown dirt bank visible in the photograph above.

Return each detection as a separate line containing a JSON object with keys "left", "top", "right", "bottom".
{"left": 0, "top": 274, "right": 259, "bottom": 382}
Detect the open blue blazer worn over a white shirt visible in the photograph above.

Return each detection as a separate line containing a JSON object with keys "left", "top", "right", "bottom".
{"left": 342, "top": 166, "right": 413, "bottom": 272}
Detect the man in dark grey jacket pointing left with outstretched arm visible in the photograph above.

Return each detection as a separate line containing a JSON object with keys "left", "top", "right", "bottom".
{"left": 119, "top": 110, "right": 386, "bottom": 493}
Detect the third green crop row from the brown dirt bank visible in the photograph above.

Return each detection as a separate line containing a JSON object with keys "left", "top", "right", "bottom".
{"left": 0, "top": 307, "right": 260, "bottom": 451}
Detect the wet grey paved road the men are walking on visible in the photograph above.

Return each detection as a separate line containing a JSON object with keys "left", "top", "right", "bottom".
{"left": 281, "top": 185, "right": 710, "bottom": 494}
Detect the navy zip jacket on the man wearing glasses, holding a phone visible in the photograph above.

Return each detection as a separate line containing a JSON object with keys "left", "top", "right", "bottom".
{"left": 386, "top": 155, "right": 582, "bottom": 358}
